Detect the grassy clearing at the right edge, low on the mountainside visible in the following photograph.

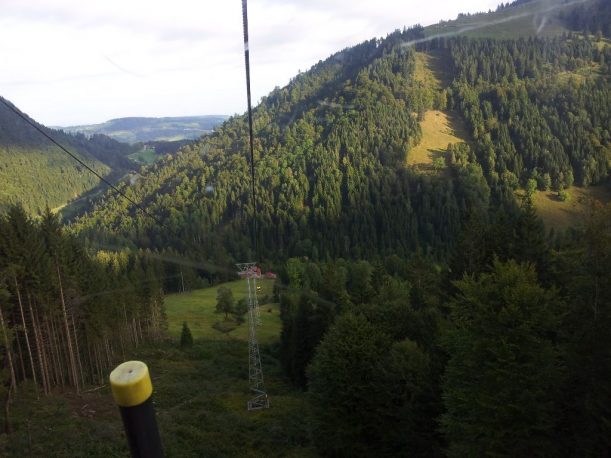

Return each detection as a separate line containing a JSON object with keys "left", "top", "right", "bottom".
{"left": 533, "top": 185, "right": 611, "bottom": 231}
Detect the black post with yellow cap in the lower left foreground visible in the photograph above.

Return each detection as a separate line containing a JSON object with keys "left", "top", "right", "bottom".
{"left": 110, "top": 361, "right": 163, "bottom": 458}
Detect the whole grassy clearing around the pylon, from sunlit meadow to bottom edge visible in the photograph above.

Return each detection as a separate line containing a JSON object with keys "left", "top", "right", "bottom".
{"left": 0, "top": 280, "right": 316, "bottom": 457}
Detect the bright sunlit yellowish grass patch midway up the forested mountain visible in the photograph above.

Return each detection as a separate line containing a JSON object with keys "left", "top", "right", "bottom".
{"left": 406, "top": 110, "right": 467, "bottom": 172}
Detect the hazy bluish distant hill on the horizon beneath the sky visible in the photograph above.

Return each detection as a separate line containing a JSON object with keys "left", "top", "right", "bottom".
{"left": 59, "top": 115, "right": 227, "bottom": 143}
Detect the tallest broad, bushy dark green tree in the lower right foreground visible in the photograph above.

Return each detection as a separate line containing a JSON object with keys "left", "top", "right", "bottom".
{"left": 441, "top": 261, "right": 562, "bottom": 456}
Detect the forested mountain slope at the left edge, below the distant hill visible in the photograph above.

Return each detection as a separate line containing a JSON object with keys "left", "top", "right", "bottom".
{"left": 0, "top": 98, "right": 133, "bottom": 213}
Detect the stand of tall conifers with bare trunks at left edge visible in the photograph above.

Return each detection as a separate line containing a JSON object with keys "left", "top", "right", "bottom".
{"left": 0, "top": 206, "right": 165, "bottom": 404}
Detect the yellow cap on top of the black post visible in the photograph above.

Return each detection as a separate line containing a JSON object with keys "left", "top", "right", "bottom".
{"left": 110, "top": 361, "right": 153, "bottom": 407}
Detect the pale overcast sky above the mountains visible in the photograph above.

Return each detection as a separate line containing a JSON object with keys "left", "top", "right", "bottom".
{"left": 0, "top": 0, "right": 500, "bottom": 126}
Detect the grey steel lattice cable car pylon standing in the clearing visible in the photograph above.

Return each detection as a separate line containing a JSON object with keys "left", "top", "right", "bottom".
{"left": 236, "top": 262, "right": 269, "bottom": 410}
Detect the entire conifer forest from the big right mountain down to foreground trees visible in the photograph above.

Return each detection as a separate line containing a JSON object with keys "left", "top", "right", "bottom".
{"left": 0, "top": 0, "right": 611, "bottom": 457}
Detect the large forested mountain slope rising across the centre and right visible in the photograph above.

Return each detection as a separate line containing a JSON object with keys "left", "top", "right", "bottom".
{"left": 75, "top": 23, "right": 611, "bottom": 268}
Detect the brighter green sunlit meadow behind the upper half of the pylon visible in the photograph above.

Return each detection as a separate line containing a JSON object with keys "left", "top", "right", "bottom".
{"left": 165, "top": 279, "right": 280, "bottom": 344}
